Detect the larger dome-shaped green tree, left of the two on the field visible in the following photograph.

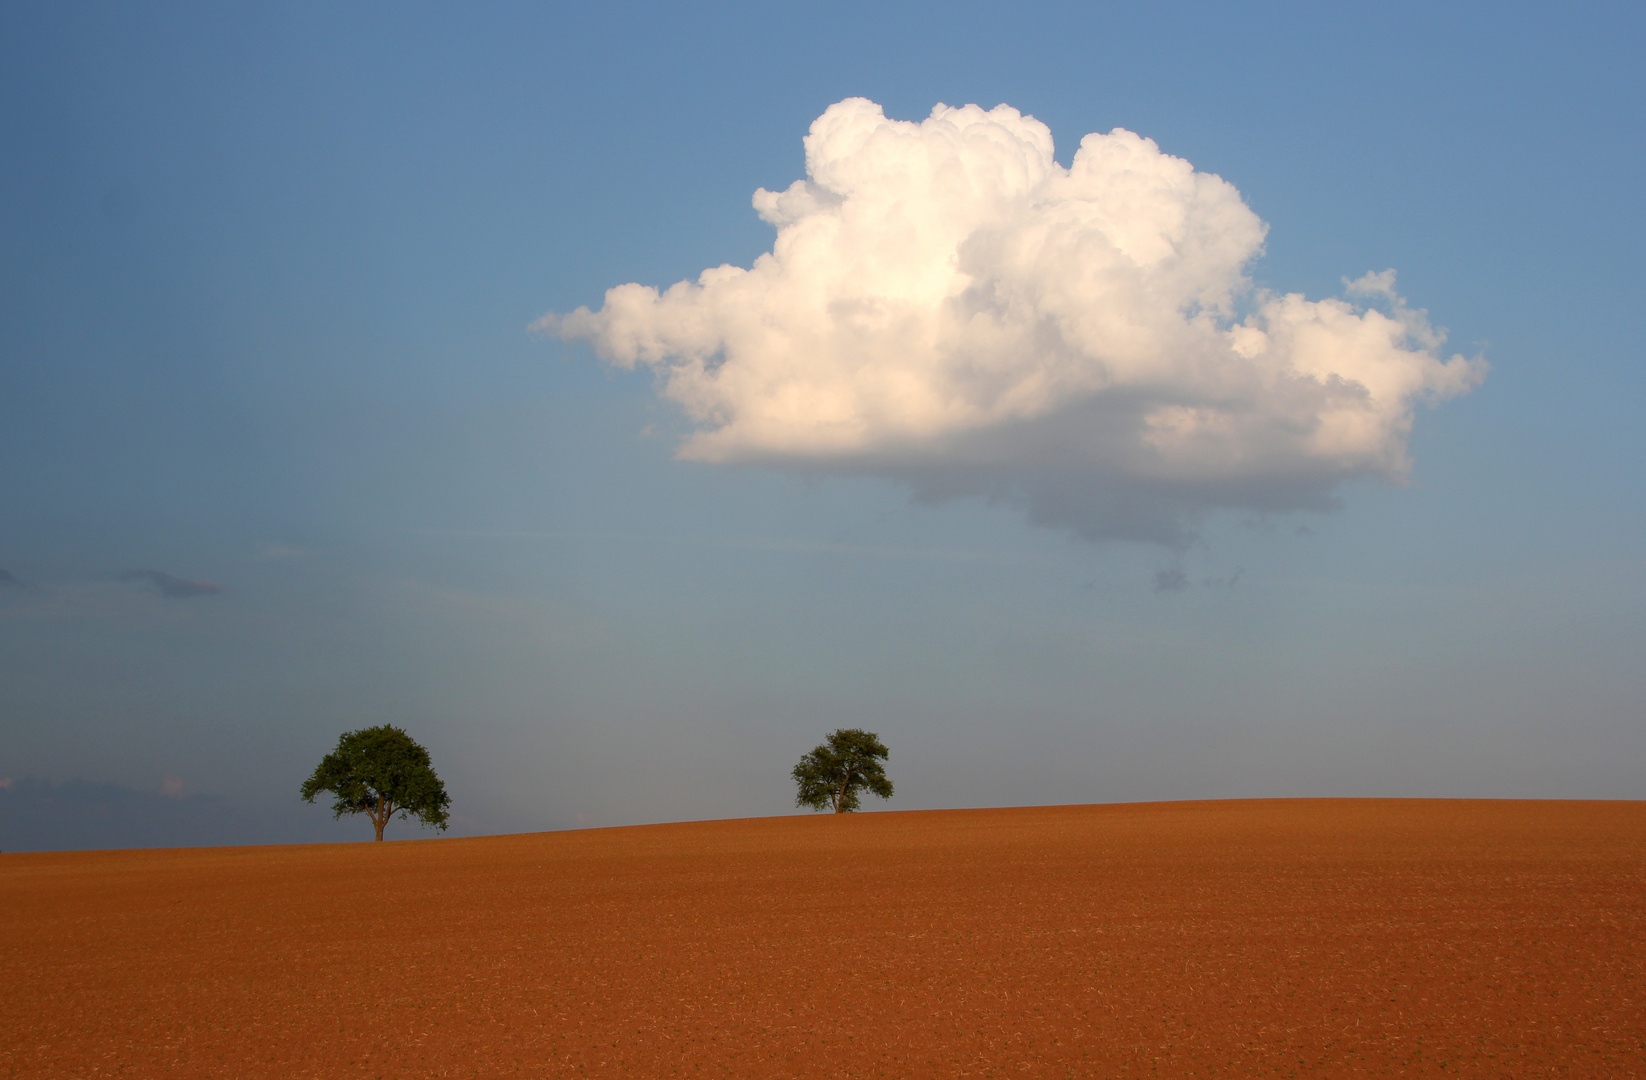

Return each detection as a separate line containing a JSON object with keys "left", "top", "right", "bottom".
{"left": 303, "top": 724, "right": 451, "bottom": 840}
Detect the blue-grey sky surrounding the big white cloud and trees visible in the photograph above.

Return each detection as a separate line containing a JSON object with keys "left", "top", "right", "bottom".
{"left": 0, "top": 3, "right": 1646, "bottom": 850}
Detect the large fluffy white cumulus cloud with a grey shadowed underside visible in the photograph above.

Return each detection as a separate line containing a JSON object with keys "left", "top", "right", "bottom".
{"left": 537, "top": 99, "right": 1485, "bottom": 542}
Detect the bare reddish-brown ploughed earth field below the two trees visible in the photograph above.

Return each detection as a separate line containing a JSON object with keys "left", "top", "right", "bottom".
{"left": 0, "top": 800, "right": 1646, "bottom": 1078}
